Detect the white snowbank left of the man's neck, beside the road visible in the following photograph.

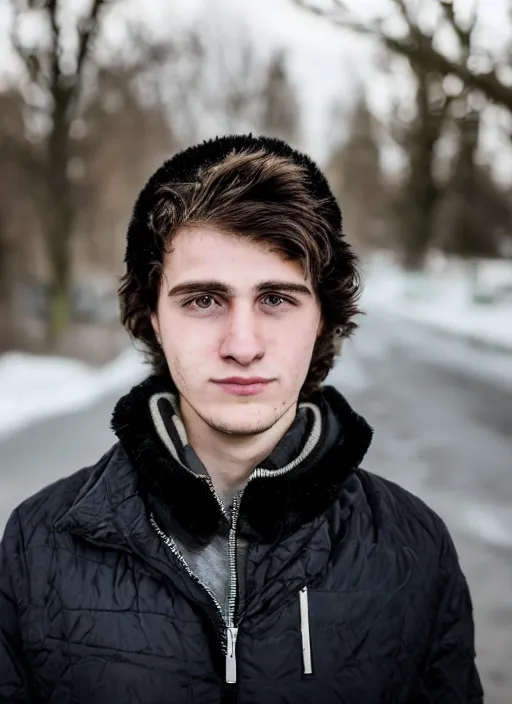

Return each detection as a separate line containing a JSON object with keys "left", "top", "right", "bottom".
{"left": 0, "top": 348, "right": 148, "bottom": 439}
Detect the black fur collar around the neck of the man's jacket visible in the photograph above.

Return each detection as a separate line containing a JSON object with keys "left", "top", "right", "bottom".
{"left": 112, "top": 377, "right": 373, "bottom": 543}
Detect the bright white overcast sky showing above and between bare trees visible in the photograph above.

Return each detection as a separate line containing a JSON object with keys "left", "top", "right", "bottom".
{"left": 0, "top": 0, "right": 512, "bottom": 171}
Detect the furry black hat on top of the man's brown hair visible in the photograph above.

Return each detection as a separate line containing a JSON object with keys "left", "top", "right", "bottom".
{"left": 125, "top": 134, "right": 342, "bottom": 281}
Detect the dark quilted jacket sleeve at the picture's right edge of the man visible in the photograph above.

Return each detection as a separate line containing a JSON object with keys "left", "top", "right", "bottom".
{"left": 414, "top": 528, "right": 483, "bottom": 704}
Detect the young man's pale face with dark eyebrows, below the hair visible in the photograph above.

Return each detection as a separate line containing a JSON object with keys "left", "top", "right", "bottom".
{"left": 152, "top": 226, "right": 321, "bottom": 435}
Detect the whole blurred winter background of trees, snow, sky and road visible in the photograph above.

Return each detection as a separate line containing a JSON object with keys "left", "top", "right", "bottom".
{"left": 0, "top": 0, "right": 512, "bottom": 704}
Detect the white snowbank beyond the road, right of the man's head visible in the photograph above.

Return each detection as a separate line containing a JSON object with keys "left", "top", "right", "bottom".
{"left": 362, "top": 254, "right": 512, "bottom": 351}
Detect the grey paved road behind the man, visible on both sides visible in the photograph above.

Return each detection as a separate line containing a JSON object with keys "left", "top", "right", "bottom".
{"left": 0, "top": 314, "right": 512, "bottom": 704}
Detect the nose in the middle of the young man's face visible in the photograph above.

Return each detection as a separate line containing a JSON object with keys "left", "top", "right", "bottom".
{"left": 220, "top": 305, "right": 264, "bottom": 367}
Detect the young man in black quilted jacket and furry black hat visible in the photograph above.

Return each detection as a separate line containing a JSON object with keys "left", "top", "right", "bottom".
{"left": 0, "top": 136, "right": 482, "bottom": 704}
